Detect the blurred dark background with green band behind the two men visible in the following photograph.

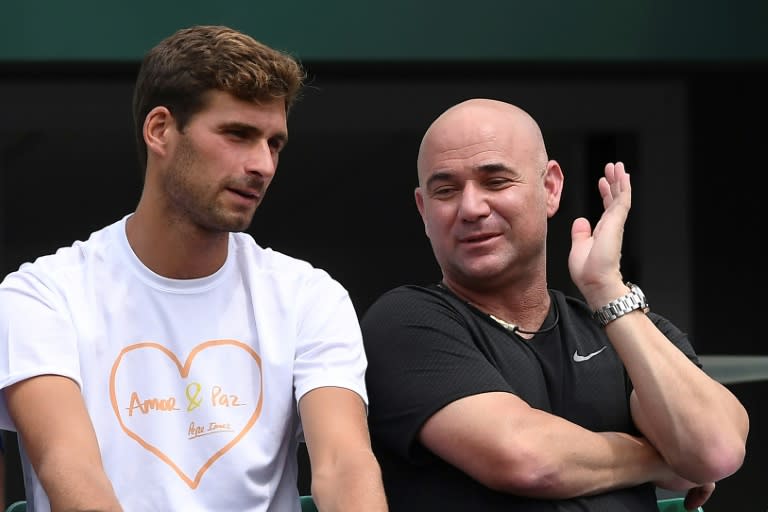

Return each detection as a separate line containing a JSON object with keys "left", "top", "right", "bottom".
{"left": 0, "top": 0, "right": 768, "bottom": 512}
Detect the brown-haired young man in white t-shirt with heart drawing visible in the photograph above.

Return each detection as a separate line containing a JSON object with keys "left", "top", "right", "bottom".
{"left": 0, "top": 26, "right": 386, "bottom": 512}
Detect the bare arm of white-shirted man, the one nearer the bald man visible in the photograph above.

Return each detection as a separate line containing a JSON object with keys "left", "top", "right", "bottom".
{"left": 299, "top": 387, "right": 387, "bottom": 512}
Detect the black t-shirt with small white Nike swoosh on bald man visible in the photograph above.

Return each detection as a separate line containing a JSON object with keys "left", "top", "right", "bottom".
{"left": 361, "top": 286, "right": 698, "bottom": 512}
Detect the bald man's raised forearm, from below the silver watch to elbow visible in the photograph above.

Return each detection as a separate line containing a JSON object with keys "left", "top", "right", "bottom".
{"left": 606, "top": 313, "right": 749, "bottom": 483}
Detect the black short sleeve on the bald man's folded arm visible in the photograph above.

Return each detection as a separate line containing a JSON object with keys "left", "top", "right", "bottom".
{"left": 361, "top": 287, "right": 514, "bottom": 461}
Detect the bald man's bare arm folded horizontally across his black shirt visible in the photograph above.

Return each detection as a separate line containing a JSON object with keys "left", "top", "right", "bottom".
{"left": 420, "top": 392, "right": 672, "bottom": 499}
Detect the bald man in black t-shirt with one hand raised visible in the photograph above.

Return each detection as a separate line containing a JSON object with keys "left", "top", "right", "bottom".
{"left": 362, "top": 99, "right": 749, "bottom": 512}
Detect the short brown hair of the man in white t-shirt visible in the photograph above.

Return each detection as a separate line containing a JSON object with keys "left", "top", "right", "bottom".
{"left": 133, "top": 25, "right": 305, "bottom": 167}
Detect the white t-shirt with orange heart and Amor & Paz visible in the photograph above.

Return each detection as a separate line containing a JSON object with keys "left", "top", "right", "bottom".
{"left": 0, "top": 217, "right": 367, "bottom": 512}
